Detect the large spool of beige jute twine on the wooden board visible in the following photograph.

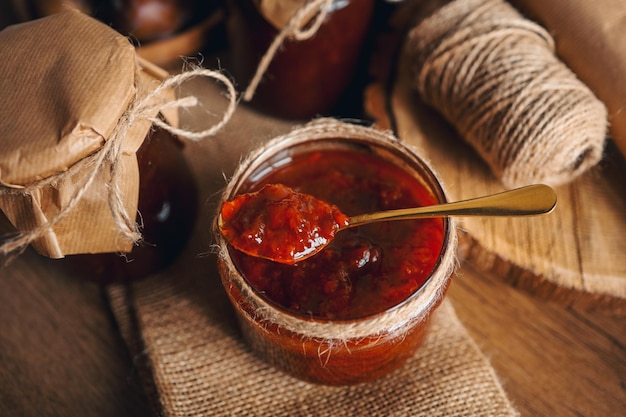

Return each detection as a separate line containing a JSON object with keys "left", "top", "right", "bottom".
{"left": 406, "top": 0, "right": 607, "bottom": 187}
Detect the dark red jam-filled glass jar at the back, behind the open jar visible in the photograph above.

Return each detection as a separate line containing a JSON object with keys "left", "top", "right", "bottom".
{"left": 228, "top": 0, "right": 374, "bottom": 119}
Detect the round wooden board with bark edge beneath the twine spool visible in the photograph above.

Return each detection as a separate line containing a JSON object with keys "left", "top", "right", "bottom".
{"left": 365, "top": 39, "right": 626, "bottom": 314}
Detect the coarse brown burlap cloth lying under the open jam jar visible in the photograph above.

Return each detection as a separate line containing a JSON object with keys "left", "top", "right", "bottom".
{"left": 108, "top": 80, "right": 517, "bottom": 416}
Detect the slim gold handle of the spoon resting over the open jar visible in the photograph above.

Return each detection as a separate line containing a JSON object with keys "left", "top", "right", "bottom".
{"left": 348, "top": 184, "right": 557, "bottom": 227}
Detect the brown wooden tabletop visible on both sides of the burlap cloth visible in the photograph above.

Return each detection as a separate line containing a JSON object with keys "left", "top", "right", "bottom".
{"left": 0, "top": 4, "right": 626, "bottom": 417}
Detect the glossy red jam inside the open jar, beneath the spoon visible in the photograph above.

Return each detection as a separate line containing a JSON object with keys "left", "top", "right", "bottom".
{"left": 224, "top": 150, "right": 444, "bottom": 320}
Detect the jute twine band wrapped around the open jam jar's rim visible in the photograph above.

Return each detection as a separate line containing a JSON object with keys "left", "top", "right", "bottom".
{"left": 213, "top": 118, "right": 457, "bottom": 346}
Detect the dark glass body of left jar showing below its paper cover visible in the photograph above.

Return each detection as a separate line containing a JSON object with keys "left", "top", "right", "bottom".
{"left": 62, "top": 129, "right": 197, "bottom": 283}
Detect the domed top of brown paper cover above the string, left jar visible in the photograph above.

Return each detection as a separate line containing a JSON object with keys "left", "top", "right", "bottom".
{"left": 0, "top": 11, "right": 140, "bottom": 186}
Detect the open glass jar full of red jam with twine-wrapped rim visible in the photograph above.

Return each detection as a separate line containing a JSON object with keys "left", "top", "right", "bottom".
{"left": 217, "top": 123, "right": 456, "bottom": 385}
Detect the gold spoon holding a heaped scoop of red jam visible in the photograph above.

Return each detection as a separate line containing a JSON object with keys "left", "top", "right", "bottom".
{"left": 217, "top": 184, "right": 557, "bottom": 264}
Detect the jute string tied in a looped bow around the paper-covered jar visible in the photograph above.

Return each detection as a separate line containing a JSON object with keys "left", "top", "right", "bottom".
{"left": 0, "top": 65, "right": 237, "bottom": 255}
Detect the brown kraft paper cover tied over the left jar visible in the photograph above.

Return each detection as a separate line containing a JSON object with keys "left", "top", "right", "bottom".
{"left": 0, "top": 11, "right": 171, "bottom": 258}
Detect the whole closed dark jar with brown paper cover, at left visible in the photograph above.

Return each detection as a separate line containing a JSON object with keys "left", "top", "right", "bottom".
{"left": 0, "top": 10, "right": 197, "bottom": 281}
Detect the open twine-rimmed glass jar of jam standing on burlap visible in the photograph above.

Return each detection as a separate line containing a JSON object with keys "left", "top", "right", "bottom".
{"left": 217, "top": 123, "right": 457, "bottom": 385}
